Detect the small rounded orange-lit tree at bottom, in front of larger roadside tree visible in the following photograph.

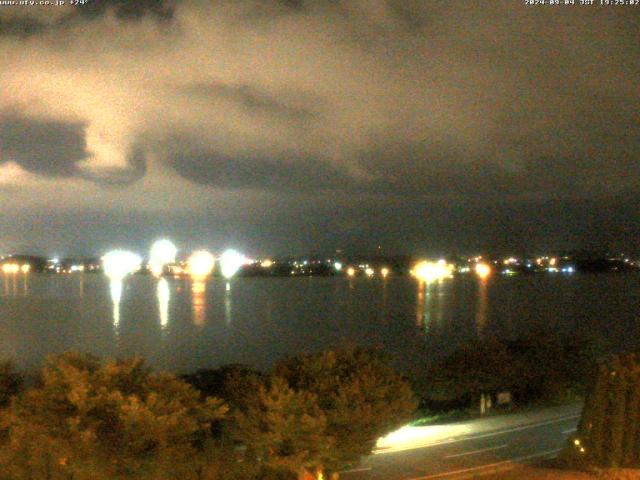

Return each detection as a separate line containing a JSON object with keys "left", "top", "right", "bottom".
{"left": 233, "top": 377, "right": 333, "bottom": 477}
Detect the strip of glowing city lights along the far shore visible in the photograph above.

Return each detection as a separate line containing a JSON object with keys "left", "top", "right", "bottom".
{"left": 0, "top": 248, "right": 640, "bottom": 282}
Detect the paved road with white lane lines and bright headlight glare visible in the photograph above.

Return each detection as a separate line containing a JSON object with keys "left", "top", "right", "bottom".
{"left": 341, "top": 404, "right": 581, "bottom": 480}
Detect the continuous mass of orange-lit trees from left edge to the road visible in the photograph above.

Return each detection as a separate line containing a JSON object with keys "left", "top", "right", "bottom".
{"left": 0, "top": 348, "right": 416, "bottom": 480}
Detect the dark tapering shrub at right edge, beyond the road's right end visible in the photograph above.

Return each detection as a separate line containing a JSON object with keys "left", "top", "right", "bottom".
{"left": 564, "top": 354, "right": 640, "bottom": 468}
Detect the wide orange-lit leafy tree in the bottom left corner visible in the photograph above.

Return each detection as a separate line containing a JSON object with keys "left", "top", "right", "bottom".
{"left": 2, "top": 353, "right": 226, "bottom": 480}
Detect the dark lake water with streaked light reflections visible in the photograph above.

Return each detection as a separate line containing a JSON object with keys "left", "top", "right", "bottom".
{"left": 0, "top": 274, "right": 640, "bottom": 372}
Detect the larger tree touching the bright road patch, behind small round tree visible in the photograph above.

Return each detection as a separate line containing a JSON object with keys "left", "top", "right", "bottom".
{"left": 275, "top": 348, "right": 416, "bottom": 470}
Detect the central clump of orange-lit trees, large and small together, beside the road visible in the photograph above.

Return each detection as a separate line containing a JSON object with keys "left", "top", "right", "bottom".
{"left": 185, "top": 348, "right": 416, "bottom": 475}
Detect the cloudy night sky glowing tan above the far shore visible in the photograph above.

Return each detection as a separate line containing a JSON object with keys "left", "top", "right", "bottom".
{"left": 0, "top": 0, "right": 640, "bottom": 255}
